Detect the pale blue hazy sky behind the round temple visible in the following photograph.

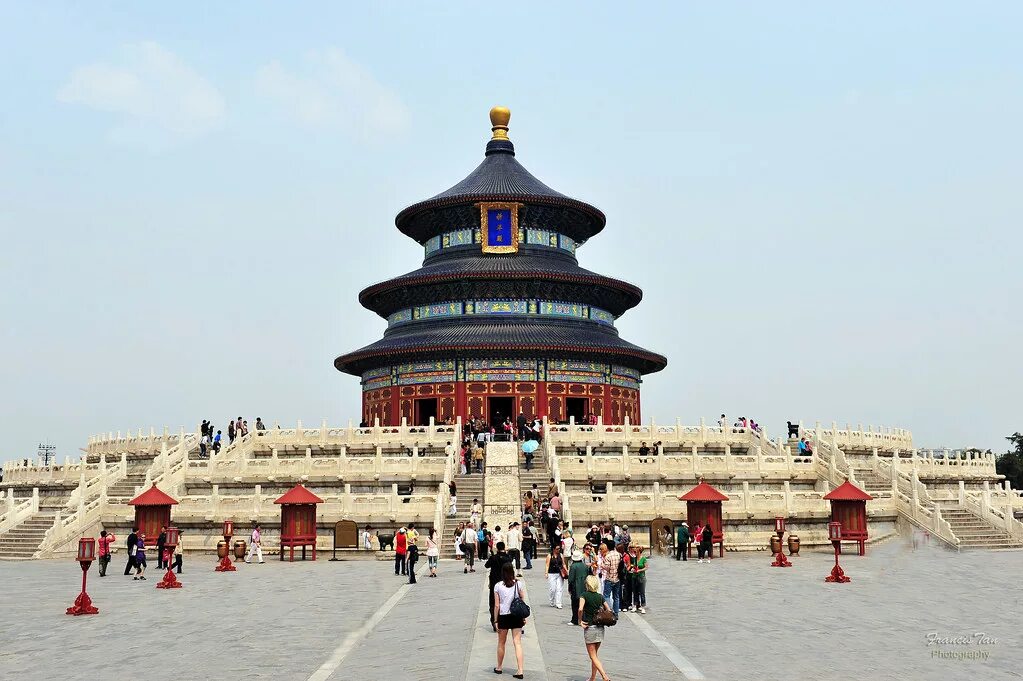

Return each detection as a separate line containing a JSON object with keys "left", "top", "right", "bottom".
{"left": 0, "top": 2, "right": 1023, "bottom": 460}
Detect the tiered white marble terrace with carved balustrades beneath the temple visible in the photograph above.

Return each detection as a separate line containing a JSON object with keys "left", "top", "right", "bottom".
{"left": 0, "top": 422, "right": 1023, "bottom": 557}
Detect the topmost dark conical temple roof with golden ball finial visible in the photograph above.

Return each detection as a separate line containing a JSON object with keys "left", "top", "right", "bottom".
{"left": 394, "top": 106, "right": 607, "bottom": 243}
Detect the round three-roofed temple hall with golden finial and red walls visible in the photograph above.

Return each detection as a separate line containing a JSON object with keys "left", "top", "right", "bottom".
{"left": 333, "top": 106, "right": 667, "bottom": 425}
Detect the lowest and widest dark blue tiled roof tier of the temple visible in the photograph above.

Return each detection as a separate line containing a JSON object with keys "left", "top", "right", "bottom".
{"left": 333, "top": 320, "right": 668, "bottom": 375}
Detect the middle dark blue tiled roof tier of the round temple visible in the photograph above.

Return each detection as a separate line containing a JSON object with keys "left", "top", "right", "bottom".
{"left": 359, "top": 252, "right": 642, "bottom": 317}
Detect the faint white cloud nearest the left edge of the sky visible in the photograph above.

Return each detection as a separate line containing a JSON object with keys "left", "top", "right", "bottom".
{"left": 57, "top": 42, "right": 227, "bottom": 139}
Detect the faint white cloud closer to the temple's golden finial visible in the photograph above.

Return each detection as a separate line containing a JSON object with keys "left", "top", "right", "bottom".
{"left": 256, "top": 47, "right": 409, "bottom": 139}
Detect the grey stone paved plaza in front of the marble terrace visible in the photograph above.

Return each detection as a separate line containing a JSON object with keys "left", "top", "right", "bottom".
{"left": 0, "top": 540, "right": 1023, "bottom": 681}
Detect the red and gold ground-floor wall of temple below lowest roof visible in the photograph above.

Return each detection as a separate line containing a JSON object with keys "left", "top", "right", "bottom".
{"left": 362, "top": 381, "right": 640, "bottom": 425}
